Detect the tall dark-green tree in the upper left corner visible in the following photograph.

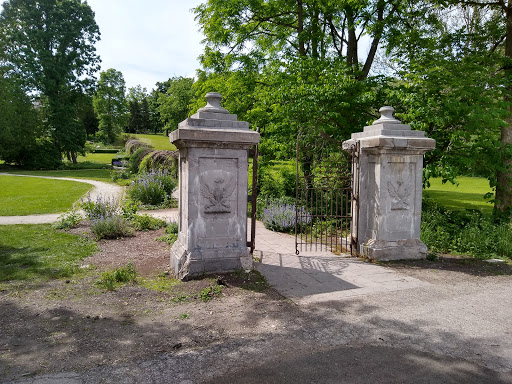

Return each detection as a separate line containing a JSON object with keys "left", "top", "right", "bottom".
{"left": 0, "top": 0, "right": 100, "bottom": 161}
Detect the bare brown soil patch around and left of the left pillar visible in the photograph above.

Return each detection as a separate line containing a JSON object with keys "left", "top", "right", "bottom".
{"left": 0, "top": 227, "right": 288, "bottom": 382}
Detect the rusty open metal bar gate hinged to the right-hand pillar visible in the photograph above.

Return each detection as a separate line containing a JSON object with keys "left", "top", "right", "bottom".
{"left": 295, "top": 134, "right": 358, "bottom": 255}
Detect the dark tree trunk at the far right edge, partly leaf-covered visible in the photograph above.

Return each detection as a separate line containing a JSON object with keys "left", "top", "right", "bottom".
{"left": 494, "top": 0, "right": 512, "bottom": 216}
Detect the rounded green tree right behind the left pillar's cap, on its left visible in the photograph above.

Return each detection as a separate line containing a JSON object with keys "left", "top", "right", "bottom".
{"left": 157, "top": 77, "right": 194, "bottom": 131}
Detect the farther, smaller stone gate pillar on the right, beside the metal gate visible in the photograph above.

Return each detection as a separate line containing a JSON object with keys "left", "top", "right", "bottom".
{"left": 343, "top": 107, "right": 435, "bottom": 260}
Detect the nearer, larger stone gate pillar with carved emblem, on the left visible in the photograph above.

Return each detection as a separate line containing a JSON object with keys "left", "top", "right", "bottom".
{"left": 169, "top": 92, "right": 259, "bottom": 279}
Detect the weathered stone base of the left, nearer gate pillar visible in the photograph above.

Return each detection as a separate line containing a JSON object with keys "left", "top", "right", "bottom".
{"left": 171, "top": 239, "right": 253, "bottom": 281}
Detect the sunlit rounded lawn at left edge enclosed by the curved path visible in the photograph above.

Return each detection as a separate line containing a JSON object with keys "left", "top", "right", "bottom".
{"left": 0, "top": 175, "right": 92, "bottom": 216}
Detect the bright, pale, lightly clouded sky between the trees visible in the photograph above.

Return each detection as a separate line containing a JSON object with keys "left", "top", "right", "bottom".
{"left": 87, "top": 0, "right": 203, "bottom": 91}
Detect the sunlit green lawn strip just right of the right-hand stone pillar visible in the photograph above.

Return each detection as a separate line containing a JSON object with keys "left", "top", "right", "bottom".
{"left": 424, "top": 177, "right": 493, "bottom": 214}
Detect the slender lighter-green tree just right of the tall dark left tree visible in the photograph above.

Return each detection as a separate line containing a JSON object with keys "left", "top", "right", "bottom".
{"left": 93, "top": 68, "right": 128, "bottom": 143}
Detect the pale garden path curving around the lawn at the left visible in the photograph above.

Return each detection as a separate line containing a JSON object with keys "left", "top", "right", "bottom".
{"left": 0, "top": 173, "right": 124, "bottom": 225}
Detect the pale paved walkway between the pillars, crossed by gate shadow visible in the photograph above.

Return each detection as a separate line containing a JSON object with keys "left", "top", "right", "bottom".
{"left": 254, "top": 222, "right": 428, "bottom": 304}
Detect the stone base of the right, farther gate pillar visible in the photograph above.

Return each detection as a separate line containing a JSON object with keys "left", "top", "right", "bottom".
{"left": 362, "top": 239, "right": 427, "bottom": 261}
